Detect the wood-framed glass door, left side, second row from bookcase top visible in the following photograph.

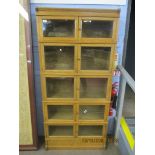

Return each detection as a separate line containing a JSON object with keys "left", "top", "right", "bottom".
{"left": 40, "top": 43, "right": 77, "bottom": 74}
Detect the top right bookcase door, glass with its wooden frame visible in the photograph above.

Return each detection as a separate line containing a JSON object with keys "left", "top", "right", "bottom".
{"left": 79, "top": 17, "right": 117, "bottom": 43}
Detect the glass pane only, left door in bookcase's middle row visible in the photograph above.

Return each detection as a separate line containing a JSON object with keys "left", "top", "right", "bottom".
{"left": 46, "top": 78, "right": 74, "bottom": 98}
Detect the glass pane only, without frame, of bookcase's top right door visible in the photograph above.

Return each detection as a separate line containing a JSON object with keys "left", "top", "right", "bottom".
{"left": 82, "top": 20, "right": 113, "bottom": 38}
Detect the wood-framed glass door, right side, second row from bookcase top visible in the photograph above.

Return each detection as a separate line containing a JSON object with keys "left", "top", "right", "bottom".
{"left": 78, "top": 44, "right": 114, "bottom": 75}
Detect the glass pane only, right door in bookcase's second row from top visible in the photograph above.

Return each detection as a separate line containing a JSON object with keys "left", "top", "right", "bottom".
{"left": 81, "top": 47, "right": 111, "bottom": 70}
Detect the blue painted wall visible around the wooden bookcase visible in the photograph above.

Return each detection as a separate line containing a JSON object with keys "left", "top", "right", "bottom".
{"left": 30, "top": 3, "right": 127, "bottom": 135}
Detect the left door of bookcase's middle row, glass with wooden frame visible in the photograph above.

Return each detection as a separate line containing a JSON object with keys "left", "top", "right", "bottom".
{"left": 42, "top": 75, "right": 76, "bottom": 101}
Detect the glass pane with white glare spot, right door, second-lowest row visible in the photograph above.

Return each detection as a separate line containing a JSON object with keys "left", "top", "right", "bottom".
{"left": 79, "top": 105, "right": 104, "bottom": 120}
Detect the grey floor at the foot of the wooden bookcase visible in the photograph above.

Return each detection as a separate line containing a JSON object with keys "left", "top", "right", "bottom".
{"left": 19, "top": 144, "right": 120, "bottom": 155}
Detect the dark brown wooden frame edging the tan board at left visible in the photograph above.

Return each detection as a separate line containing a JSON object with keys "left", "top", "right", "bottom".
{"left": 19, "top": 0, "right": 38, "bottom": 151}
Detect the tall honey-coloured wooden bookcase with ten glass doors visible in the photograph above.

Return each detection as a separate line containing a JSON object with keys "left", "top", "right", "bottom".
{"left": 36, "top": 8, "right": 119, "bottom": 149}
